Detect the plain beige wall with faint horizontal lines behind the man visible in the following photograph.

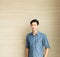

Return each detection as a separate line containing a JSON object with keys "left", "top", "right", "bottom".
{"left": 0, "top": 0, "right": 60, "bottom": 57}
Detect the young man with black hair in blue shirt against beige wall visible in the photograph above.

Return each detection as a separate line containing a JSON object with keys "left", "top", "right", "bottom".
{"left": 26, "top": 19, "right": 50, "bottom": 57}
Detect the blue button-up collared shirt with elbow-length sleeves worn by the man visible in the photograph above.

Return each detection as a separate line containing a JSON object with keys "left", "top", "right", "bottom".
{"left": 26, "top": 32, "right": 50, "bottom": 57}
